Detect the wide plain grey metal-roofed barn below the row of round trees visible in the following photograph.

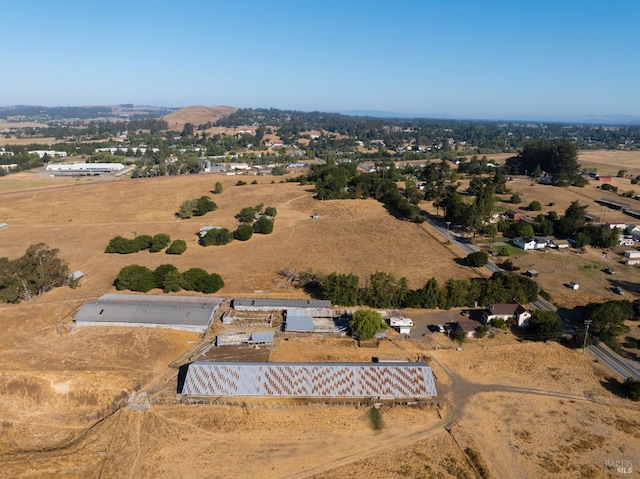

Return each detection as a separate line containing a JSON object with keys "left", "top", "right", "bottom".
{"left": 74, "top": 294, "right": 222, "bottom": 332}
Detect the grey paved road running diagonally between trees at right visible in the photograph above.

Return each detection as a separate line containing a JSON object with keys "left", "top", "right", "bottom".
{"left": 428, "top": 220, "right": 640, "bottom": 380}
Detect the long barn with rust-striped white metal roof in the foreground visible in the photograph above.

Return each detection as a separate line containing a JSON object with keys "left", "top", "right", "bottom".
{"left": 182, "top": 361, "right": 437, "bottom": 399}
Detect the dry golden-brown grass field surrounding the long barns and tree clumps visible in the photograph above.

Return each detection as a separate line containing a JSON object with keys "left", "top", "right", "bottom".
{"left": 0, "top": 156, "right": 640, "bottom": 479}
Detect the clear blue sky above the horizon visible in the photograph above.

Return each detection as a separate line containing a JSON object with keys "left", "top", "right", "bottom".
{"left": 0, "top": 0, "right": 640, "bottom": 118}
